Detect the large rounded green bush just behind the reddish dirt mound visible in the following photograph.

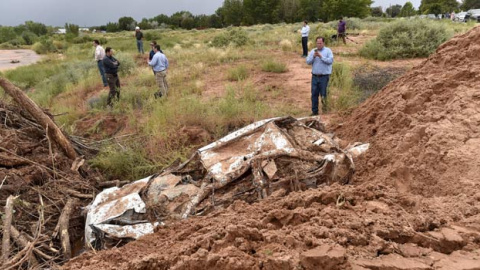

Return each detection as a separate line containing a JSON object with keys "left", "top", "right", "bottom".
{"left": 360, "top": 20, "right": 453, "bottom": 60}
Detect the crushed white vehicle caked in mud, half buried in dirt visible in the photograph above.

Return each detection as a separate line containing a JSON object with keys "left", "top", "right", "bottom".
{"left": 85, "top": 117, "right": 369, "bottom": 249}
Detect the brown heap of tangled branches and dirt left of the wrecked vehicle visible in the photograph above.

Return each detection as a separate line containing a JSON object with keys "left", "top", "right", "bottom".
{"left": 0, "top": 98, "right": 97, "bottom": 269}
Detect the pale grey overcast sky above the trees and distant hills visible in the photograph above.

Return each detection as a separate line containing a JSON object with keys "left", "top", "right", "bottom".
{"left": 0, "top": 0, "right": 421, "bottom": 26}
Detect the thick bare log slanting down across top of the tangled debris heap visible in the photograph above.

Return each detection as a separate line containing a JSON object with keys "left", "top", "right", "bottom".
{"left": 0, "top": 78, "right": 77, "bottom": 159}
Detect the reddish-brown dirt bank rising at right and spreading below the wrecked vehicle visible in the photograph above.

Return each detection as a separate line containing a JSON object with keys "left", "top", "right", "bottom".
{"left": 64, "top": 27, "right": 480, "bottom": 269}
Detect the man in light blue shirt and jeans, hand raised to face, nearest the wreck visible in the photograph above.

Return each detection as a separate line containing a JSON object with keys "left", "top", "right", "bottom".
{"left": 307, "top": 37, "right": 333, "bottom": 116}
